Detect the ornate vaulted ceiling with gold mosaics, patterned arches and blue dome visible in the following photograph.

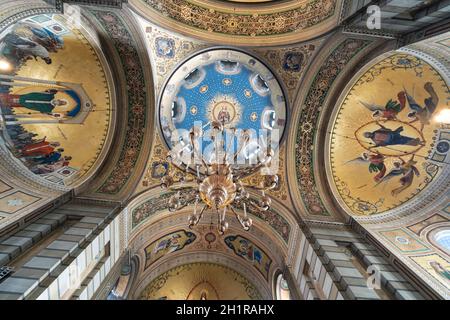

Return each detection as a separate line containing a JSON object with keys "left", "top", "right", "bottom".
{"left": 0, "top": 0, "right": 449, "bottom": 299}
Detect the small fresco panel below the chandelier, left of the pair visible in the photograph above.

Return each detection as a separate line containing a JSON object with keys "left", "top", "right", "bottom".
{"left": 145, "top": 230, "right": 197, "bottom": 268}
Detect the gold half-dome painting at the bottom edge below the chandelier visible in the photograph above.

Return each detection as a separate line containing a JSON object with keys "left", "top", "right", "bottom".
{"left": 139, "top": 263, "right": 262, "bottom": 300}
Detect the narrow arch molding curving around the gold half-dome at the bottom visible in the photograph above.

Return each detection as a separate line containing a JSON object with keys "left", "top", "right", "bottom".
{"left": 129, "top": 251, "right": 272, "bottom": 300}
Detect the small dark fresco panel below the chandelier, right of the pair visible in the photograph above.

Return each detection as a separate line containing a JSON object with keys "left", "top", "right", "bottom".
{"left": 224, "top": 235, "right": 272, "bottom": 280}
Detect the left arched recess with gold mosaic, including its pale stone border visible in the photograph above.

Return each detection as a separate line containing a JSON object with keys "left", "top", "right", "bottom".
{"left": 0, "top": 7, "right": 125, "bottom": 232}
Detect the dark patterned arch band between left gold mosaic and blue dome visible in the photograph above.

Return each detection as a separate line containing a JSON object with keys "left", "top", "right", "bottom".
{"left": 76, "top": 7, "right": 155, "bottom": 200}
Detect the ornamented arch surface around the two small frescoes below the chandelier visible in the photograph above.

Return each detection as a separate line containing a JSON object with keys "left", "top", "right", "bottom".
{"left": 125, "top": 202, "right": 288, "bottom": 297}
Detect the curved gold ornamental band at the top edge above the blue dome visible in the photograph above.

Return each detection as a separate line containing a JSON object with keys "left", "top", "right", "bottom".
{"left": 128, "top": 0, "right": 342, "bottom": 46}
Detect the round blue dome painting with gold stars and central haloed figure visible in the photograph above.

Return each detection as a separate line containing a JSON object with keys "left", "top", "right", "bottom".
{"left": 159, "top": 49, "right": 286, "bottom": 166}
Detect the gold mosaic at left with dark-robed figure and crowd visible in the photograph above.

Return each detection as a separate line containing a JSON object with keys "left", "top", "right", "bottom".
{"left": 0, "top": 14, "right": 111, "bottom": 185}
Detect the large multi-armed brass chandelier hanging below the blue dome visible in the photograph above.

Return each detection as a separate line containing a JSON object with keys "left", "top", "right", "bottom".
{"left": 160, "top": 121, "right": 279, "bottom": 235}
